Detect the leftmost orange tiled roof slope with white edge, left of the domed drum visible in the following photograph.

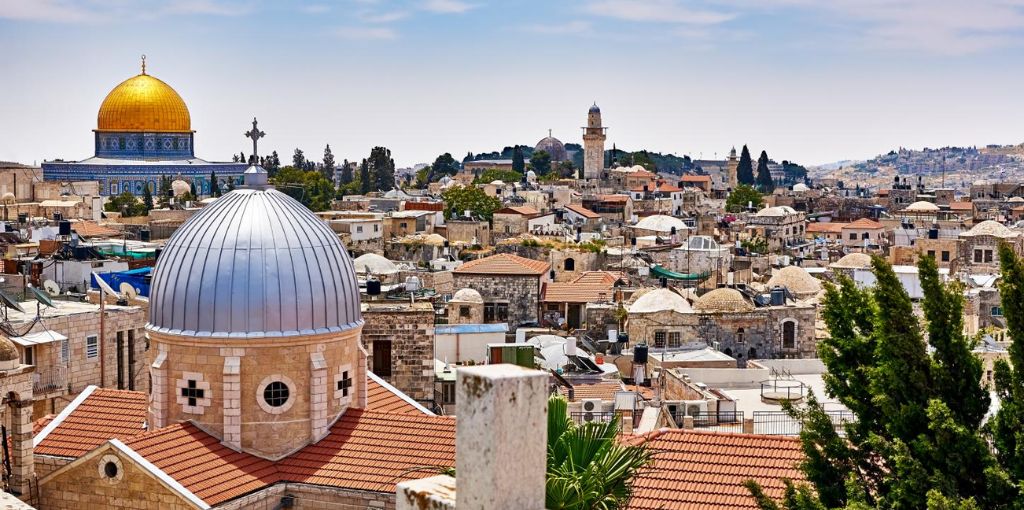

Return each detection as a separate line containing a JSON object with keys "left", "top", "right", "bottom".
{"left": 36, "top": 386, "right": 148, "bottom": 457}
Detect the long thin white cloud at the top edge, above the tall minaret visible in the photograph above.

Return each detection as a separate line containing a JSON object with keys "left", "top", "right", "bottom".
{"left": 584, "top": 0, "right": 736, "bottom": 25}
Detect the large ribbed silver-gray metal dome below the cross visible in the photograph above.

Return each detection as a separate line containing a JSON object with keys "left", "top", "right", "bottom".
{"left": 146, "top": 188, "right": 362, "bottom": 338}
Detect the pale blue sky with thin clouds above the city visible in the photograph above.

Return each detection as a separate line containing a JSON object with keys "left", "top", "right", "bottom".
{"left": 0, "top": 0, "right": 1024, "bottom": 165}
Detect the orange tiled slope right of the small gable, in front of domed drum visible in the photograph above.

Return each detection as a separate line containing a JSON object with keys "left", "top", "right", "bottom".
{"left": 124, "top": 422, "right": 279, "bottom": 505}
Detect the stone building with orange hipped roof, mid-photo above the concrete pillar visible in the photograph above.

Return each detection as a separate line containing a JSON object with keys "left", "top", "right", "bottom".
{"left": 453, "top": 253, "right": 551, "bottom": 329}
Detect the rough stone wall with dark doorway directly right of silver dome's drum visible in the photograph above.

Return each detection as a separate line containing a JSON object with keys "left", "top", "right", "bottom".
{"left": 362, "top": 301, "right": 434, "bottom": 400}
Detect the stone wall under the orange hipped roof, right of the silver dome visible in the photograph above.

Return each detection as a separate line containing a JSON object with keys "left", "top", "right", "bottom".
{"left": 454, "top": 272, "right": 541, "bottom": 330}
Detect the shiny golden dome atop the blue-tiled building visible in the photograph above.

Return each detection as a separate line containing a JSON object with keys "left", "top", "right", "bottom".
{"left": 96, "top": 72, "right": 191, "bottom": 133}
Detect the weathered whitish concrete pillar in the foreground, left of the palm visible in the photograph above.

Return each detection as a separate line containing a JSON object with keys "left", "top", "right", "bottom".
{"left": 456, "top": 365, "right": 549, "bottom": 510}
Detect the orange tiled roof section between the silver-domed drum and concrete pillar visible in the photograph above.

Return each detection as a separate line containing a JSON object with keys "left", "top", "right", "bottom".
{"left": 278, "top": 409, "right": 455, "bottom": 494}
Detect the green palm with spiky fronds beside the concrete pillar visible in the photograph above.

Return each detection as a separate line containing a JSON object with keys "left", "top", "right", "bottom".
{"left": 545, "top": 396, "right": 651, "bottom": 510}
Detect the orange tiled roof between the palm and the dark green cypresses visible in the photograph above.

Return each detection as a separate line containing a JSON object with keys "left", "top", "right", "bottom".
{"left": 627, "top": 429, "right": 806, "bottom": 510}
